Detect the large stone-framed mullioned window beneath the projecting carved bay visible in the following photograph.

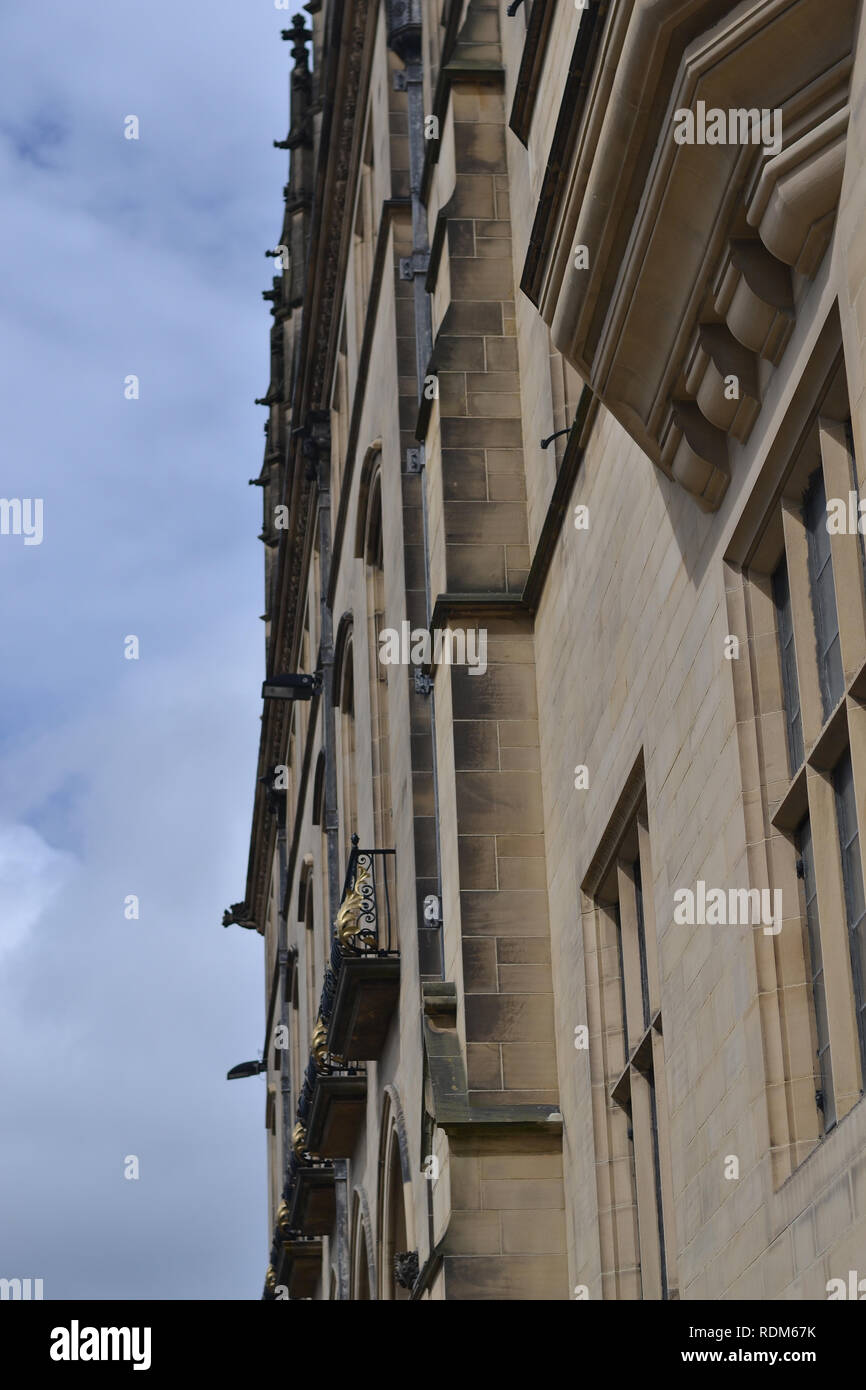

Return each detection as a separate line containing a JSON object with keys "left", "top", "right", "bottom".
{"left": 730, "top": 353, "right": 866, "bottom": 1167}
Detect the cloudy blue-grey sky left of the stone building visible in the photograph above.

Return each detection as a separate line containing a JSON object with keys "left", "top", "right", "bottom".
{"left": 0, "top": 0, "right": 291, "bottom": 1298}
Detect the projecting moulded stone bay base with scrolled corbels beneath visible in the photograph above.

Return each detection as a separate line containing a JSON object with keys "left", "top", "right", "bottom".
{"left": 539, "top": 0, "right": 858, "bottom": 510}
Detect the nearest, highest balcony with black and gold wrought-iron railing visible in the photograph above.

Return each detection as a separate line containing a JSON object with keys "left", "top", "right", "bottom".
{"left": 321, "top": 835, "right": 400, "bottom": 1056}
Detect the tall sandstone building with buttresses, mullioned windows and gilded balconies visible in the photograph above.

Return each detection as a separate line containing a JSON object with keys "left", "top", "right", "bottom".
{"left": 225, "top": 0, "right": 866, "bottom": 1300}
